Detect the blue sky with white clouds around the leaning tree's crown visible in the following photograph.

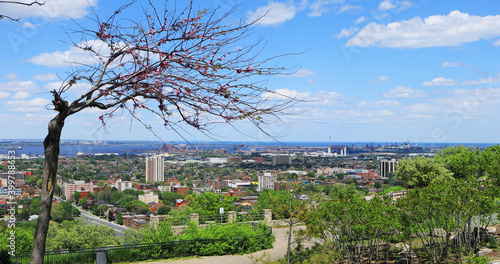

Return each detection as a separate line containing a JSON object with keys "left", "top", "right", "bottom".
{"left": 0, "top": 0, "right": 500, "bottom": 143}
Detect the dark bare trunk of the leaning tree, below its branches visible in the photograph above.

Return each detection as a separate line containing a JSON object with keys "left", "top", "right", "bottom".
{"left": 31, "top": 116, "right": 64, "bottom": 264}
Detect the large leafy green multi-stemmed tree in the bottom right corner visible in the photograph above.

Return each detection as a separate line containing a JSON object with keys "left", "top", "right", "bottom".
{"left": 397, "top": 177, "right": 499, "bottom": 263}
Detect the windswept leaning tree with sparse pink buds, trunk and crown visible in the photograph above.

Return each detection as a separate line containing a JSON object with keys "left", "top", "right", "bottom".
{"left": 31, "top": 1, "right": 298, "bottom": 263}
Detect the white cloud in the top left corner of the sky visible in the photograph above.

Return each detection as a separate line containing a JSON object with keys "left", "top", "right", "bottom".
{"left": 2, "top": 0, "right": 98, "bottom": 19}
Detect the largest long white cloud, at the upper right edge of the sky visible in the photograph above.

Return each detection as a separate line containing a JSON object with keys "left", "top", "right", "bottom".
{"left": 346, "top": 11, "right": 500, "bottom": 48}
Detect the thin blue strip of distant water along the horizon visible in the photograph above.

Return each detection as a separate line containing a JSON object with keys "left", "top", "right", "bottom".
{"left": 0, "top": 142, "right": 498, "bottom": 157}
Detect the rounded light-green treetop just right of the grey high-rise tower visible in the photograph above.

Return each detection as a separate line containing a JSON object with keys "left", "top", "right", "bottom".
{"left": 396, "top": 156, "right": 453, "bottom": 188}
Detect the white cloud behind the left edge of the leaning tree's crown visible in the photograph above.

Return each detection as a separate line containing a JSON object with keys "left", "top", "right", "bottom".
{"left": 29, "top": 40, "right": 109, "bottom": 67}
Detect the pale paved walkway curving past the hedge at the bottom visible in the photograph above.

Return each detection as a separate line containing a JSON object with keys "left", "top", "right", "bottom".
{"left": 132, "top": 226, "right": 307, "bottom": 264}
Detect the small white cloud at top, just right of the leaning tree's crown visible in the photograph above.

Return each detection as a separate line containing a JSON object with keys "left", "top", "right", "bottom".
{"left": 247, "top": 1, "right": 301, "bottom": 26}
